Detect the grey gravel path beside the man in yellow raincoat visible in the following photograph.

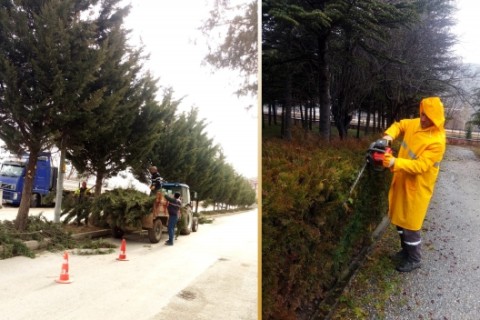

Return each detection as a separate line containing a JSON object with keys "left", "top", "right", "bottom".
{"left": 385, "top": 145, "right": 480, "bottom": 320}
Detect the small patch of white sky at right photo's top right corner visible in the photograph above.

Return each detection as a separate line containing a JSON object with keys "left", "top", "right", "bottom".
{"left": 454, "top": 0, "right": 480, "bottom": 64}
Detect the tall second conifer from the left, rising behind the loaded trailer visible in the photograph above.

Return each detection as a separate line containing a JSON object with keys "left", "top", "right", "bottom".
{"left": 62, "top": 0, "right": 162, "bottom": 195}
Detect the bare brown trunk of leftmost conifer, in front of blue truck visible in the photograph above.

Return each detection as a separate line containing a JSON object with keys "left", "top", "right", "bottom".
{"left": 15, "top": 150, "right": 39, "bottom": 231}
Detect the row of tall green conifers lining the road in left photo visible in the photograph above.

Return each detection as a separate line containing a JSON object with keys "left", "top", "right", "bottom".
{"left": 0, "top": 0, "right": 255, "bottom": 230}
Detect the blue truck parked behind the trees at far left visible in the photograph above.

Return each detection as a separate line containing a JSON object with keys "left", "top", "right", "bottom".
{"left": 0, "top": 152, "right": 58, "bottom": 207}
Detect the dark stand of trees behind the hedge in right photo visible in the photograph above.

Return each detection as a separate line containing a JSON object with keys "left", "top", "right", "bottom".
{"left": 262, "top": 0, "right": 467, "bottom": 140}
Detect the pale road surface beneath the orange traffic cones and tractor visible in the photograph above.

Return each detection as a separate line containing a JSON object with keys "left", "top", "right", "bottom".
{"left": 0, "top": 208, "right": 259, "bottom": 320}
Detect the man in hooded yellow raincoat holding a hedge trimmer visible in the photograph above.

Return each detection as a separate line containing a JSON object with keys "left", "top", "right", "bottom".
{"left": 383, "top": 97, "right": 446, "bottom": 272}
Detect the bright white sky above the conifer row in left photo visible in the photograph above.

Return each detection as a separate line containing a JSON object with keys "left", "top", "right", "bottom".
{"left": 125, "top": 0, "right": 258, "bottom": 178}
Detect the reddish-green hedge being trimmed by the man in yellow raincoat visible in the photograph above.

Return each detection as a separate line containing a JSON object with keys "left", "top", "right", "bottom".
{"left": 262, "top": 139, "right": 391, "bottom": 320}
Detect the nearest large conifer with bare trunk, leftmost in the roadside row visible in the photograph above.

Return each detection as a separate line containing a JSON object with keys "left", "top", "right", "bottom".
{"left": 0, "top": 0, "right": 102, "bottom": 230}
